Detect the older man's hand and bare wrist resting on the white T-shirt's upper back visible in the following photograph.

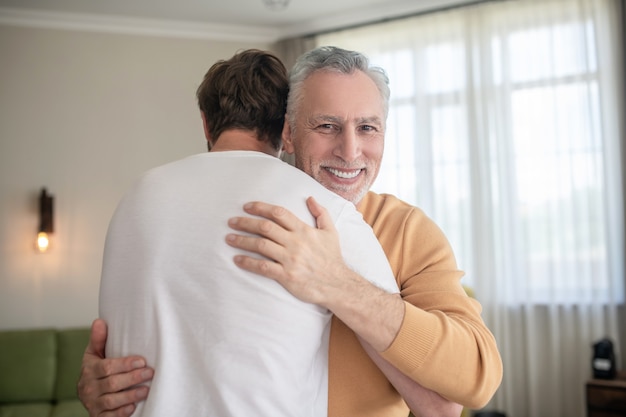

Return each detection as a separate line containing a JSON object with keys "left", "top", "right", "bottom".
{"left": 226, "top": 197, "right": 404, "bottom": 352}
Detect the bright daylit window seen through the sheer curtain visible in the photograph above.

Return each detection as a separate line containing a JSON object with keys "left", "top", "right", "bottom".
{"left": 318, "top": 2, "right": 624, "bottom": 304}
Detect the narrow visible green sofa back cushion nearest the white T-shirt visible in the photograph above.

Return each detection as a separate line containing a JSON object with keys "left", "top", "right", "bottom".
{"left": 54, "top": 328, "right": 89, "bottom": 400}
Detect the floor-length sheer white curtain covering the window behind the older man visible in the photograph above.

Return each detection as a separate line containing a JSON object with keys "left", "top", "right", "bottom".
{"left": 317, "top": 0, "right": 626, "bottom": 417}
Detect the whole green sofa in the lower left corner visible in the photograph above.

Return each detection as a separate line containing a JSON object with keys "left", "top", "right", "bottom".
{"left": 0, "top": 328, "right": 89, "bottom": 417}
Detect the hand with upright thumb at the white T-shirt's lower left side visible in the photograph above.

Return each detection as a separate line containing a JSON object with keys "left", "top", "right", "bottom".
{"left": 77, "top": 319, "right": 154, "bottom": 417}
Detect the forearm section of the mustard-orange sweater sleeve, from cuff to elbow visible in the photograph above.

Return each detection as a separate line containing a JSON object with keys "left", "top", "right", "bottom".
{"left": 381, "top": 305, "right": 502, "bottom": 408}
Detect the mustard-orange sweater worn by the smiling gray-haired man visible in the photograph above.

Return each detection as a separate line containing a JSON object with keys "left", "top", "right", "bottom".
{"left": 328, "top": 192, "right": 502, "bottom": 417}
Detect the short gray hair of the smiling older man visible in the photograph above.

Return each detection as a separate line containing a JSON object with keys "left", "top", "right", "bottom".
{"left": 287, "top": 46, "right": 390, "bottom": 129}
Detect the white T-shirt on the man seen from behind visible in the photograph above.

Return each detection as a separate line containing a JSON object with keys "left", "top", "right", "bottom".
{"left": 100, "top": 151, "right": 398, "bottom": 417}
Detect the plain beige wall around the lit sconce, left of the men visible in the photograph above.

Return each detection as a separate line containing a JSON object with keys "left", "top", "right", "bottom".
{"left": 0, "top": 25, "right": 268, "bottom": 329}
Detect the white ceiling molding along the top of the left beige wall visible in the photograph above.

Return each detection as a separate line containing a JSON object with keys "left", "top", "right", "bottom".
{"left": 0, "top": 7, "right": 281, "bottom": 42}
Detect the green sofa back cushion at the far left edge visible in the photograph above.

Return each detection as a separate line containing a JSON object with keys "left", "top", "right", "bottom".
{"left": 0, "top": 329, "right": 56, "bottom": 402}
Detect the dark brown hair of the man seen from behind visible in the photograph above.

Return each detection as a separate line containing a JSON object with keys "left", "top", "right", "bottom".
{"left": 196, "top": 49, "right": 289, "bottom": 150}
